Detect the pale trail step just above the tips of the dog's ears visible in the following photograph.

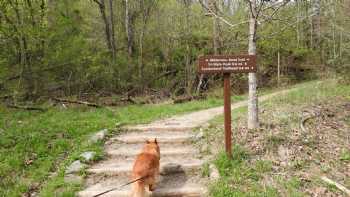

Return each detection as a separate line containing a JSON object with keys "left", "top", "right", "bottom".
{"left": 111, "top": 131, "right": 195, "bottom": 144}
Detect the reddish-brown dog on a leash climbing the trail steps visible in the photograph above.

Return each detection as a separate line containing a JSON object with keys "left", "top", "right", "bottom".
{"left": 131, "top": 139, "right": 160, "bottom": 197}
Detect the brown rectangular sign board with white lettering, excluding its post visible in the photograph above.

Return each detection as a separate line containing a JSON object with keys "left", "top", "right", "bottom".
{"left": 198, "top": 55, "right": 257, "bottom": 74}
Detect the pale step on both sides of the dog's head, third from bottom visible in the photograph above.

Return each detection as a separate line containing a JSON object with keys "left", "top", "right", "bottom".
{"left": 105, "top": 143, "right": 199, "bottom": 159}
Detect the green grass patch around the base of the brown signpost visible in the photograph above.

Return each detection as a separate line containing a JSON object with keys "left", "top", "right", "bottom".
{"left": 210, "top": 145, "right": 278, "bottom": 197}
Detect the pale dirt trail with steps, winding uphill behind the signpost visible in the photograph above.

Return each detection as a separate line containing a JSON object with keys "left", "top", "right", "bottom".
{"left": 77, "top": 88, "right": 297, "bottom": 197}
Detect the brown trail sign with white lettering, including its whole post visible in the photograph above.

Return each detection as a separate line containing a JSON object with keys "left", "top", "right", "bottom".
{"left": 199, "top": 55, "right": 257, "bottom": 158}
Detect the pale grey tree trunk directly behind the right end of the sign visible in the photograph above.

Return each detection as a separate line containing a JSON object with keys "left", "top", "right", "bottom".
{"left": 248, "top": 0, "right": 259, "bottom": 129}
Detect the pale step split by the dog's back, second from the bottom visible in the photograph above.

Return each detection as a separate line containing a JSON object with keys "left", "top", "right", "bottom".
{"left": 86, "top": 158, "right": 204, "bottom": 176}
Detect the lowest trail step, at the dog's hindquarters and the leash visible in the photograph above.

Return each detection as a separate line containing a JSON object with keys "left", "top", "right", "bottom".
{"left": 78, "top": 173, "right": 206, "bottom": 197}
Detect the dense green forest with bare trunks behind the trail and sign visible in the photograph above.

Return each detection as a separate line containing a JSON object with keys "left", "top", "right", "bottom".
{"left": 0, "top": 0, "right": 350, "bottom": 104}
